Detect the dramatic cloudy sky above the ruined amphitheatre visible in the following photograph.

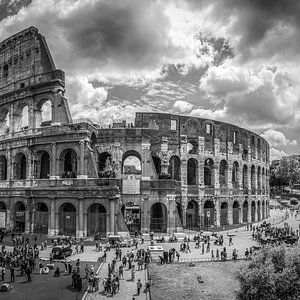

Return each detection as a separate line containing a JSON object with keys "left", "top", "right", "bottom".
{"left": 0, "top": 0, "right": 300, "bottom": 158}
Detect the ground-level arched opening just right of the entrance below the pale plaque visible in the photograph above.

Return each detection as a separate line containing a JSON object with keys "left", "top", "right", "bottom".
{"left": 150, "top": 202, "right": 168, "bottom": 233}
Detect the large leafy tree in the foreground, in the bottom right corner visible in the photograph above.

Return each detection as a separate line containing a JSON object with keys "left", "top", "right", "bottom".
{"left": 237, "top": 246, "right": 300, "bottom": 300}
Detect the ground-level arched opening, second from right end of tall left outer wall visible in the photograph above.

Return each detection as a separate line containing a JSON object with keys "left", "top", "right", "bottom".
{"left": 59, "top": 203, "right": 76, "bottom": 235}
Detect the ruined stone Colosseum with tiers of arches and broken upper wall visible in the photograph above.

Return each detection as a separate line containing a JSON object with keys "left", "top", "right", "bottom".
{"left": 0, "top": 27, "right": 269, "bottom": 237}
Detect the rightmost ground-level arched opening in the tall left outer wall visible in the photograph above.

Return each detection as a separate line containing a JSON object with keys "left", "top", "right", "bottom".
{"left": 87, "top": 203, "right": 107, "bottom": 237}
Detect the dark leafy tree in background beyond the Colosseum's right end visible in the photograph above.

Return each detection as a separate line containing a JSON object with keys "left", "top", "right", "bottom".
{"left": 274, "top": 156, "right": 300, "bottom": 192}
